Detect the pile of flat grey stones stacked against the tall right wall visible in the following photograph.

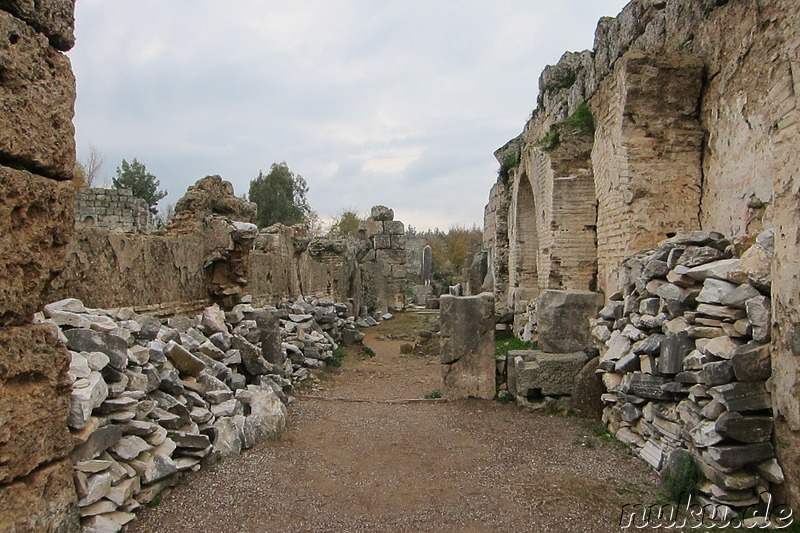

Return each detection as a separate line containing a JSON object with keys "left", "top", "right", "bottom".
{"left": 592, "top": 230, "right": 784, "bottom": 511}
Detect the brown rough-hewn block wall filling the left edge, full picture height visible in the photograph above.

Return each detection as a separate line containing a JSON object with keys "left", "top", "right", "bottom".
{"left": 0, "top": 0, "right": 78, "bottom": 533}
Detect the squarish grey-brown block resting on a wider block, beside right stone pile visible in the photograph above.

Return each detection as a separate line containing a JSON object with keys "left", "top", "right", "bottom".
{"left": 536, "top": 290, "right": 603, "bottom": 353}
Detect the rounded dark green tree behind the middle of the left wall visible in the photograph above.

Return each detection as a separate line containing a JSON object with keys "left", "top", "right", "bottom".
{"left": 248, "top": 161, "right": 311, "bottom": 228}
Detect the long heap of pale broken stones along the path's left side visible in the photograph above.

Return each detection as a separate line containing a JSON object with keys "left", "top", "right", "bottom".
{"left": 37, "top": 298, "right": 363, "bottom": 533}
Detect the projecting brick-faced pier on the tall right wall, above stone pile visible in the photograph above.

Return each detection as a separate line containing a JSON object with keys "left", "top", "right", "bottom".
{"left": 592, "top": 51, "right": 704, "bottom": 294}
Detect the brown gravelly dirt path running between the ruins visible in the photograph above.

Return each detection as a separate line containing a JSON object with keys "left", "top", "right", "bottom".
{"left": 129, "top": 310, "right": 656, "bottom": 533}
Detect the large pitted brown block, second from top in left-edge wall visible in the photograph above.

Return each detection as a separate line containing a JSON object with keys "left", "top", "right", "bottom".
{"left": 0, "top": 11, "right": 75, "bottom": 179}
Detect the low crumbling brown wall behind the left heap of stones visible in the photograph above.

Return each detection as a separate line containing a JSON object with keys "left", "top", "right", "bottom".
{"left": 46, "top": 181, "right": 406, "bottom": 317}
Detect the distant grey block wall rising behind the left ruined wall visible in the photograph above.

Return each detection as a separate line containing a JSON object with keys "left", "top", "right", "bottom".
{"left": 75, "top": 188, "right": 153, "bottom": 233}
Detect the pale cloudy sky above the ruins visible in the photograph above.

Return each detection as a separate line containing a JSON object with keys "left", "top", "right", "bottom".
{"left": 69, "top": 0, "right": 627, "bottom": 229}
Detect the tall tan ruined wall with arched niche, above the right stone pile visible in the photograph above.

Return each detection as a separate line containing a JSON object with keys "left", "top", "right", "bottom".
{"left": 484, "top": 0, "right": 800, "bottom": 505}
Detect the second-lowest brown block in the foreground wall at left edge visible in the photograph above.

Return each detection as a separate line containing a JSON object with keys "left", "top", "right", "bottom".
{"left": 0, "top": 325, "right": 71, "bottom": 482}
